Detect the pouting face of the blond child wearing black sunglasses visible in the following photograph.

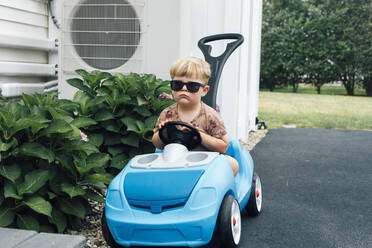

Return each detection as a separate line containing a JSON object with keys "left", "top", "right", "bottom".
{"left": 172, "top": 76, "right": 209, "bottom": 106}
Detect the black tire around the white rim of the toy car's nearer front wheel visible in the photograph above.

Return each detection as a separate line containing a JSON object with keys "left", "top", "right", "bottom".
{"left": 210, "top": 195, "right": 241, "bottom": 248}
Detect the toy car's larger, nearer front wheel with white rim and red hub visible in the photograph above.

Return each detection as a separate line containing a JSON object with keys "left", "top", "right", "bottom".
{"left": 216, "top": 195, "right": 242, "bottom": 248}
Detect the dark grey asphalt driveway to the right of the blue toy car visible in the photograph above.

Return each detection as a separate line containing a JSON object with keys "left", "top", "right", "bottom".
{"left": 240, "top": 129, "right": 372, "bottom": 248}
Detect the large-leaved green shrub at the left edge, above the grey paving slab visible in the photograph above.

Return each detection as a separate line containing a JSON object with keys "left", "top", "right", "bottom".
{"left": 0, "top": 93, "right": 112, "bottom": 232}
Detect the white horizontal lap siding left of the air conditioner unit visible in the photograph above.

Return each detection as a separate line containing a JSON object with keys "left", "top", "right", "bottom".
{"left": 0, "top": 0, "right": 57, "bottom": 97}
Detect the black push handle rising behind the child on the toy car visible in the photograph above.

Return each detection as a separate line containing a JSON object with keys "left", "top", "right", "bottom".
{"left": 198, "top": 33, "right": 244, "bottom": 109}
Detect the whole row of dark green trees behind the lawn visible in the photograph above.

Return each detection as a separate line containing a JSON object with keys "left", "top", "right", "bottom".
{"left": 261, "top": 0, "right": 372, "bottom": 96}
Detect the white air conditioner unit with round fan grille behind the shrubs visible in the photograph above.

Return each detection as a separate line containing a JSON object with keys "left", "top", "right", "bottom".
{"left": 60, "top": 0, "right": 146, "bottom": 98}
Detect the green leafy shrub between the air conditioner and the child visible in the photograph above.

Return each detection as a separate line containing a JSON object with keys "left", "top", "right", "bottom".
{"left": 67, "top": 70, "right": 173, "bottom": 175}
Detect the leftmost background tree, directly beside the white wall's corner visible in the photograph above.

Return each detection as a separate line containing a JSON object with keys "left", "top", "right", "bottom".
{"left": 261, "top": 0, "right": 305, "bottom": 92}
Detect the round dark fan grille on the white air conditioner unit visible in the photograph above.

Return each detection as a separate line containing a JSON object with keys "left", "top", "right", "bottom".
{"left": 70, "top": 0, "right": 141, "bottom": 70}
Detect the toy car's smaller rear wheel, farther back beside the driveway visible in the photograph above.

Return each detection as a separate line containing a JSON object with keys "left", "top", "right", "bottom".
{"left": 246, "top": 173, "right": 262, "bottom": 216}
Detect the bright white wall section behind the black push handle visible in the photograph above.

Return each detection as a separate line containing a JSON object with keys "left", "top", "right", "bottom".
{"left": 175, "top": 0, "right": 262, "bottom": 141}
